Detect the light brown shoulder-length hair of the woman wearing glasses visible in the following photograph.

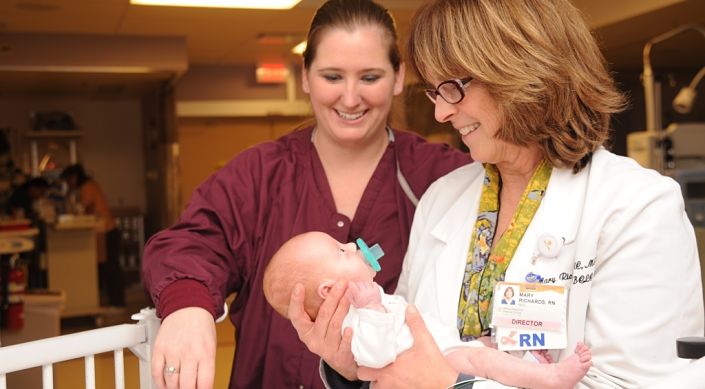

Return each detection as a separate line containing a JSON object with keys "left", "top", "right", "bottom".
{"left": 407, "top": 0, "right": 625, "bottom": 172}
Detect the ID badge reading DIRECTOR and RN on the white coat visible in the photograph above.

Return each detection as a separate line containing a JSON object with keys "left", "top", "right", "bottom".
{"left": 492, "top": 282, "right": 568, "bottom": 351}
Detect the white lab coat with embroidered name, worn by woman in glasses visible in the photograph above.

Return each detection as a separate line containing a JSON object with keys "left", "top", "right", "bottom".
{"left": 396, "top": 149, "right": 705, "bottom": 388}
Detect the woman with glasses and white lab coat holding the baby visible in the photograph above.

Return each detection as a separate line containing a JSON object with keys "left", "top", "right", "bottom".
{"left": 294, "top": 0, "right": 704, "bottom": 388}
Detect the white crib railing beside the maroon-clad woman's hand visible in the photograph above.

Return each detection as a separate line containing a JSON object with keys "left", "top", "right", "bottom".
{"left": 0, "top": 308, "right": 160, "bottom": 389}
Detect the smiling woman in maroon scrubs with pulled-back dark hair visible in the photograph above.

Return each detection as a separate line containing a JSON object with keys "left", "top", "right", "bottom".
{"left": 144, "top": 0, "right": 470, "bottom": 388}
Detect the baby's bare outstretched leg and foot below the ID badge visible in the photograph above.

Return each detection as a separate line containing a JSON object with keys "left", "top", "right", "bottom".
{"left": 446, "top": 343, "right": 592, "bottom": 389}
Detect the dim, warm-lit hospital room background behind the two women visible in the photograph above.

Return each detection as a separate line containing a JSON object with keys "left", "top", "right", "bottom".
{"left": 0, "top": 0, "right": 705, "bottom": 388}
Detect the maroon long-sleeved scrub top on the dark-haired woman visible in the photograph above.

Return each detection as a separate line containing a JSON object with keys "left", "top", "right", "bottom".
{"left": 143, "top": 128, "right": 470, "bottom": 389}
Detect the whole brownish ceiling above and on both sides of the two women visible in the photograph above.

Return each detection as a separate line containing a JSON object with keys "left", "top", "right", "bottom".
{"left": 0, "top": 0, "right": 705, "bottom": 96}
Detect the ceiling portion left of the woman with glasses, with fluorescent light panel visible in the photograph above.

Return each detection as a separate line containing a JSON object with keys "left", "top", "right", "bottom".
{"left": 0, "top": 0, "right": 421, "bottom": 65}
